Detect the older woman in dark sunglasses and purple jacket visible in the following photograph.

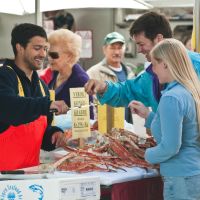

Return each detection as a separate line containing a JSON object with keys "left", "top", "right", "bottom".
{"left": 48, "top": 29, "right": 94, "bottom": 119}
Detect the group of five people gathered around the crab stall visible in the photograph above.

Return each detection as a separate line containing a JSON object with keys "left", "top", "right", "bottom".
{"left": 0, "top": 12, "right": 200, "bottom": 200}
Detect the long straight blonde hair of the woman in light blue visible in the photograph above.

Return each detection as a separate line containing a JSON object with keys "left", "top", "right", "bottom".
{"left": 150, "top": 38, "right": 200, "bottom": 131}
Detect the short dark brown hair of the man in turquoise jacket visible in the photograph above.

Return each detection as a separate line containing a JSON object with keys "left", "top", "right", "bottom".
{"left": 129, "top": 12, "right": 172, "bottom": 41}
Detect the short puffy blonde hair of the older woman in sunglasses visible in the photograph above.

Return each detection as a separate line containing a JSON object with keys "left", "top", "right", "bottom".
{"left": 48, "top": 29, "right": 82, "bottom": 64}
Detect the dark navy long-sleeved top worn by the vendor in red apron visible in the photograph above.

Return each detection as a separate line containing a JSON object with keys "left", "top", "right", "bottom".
{"left": 0, "top": 60, "right": 61, "bottom": 151}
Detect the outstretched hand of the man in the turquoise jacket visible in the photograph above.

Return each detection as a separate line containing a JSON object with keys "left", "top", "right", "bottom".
{"left": 84, "top": 79, "right": 107, "bottom": 95}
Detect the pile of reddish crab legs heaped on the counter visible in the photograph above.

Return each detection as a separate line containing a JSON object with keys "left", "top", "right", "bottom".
{"left": 52, "top": 129, "right": 156, "bottom": 173}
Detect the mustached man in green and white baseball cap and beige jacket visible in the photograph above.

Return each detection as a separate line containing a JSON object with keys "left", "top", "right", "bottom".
{"left": 87, "top": 32, "right": 133, "bottom": 122}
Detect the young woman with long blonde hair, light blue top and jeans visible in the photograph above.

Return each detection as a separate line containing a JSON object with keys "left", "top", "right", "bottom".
{"left": 129, "top": 39, "right": 200, "bottom": 200}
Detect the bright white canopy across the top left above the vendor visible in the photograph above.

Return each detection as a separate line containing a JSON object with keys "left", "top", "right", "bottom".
{"left": 0, "top": 0, "right": 153, "bottom": 15}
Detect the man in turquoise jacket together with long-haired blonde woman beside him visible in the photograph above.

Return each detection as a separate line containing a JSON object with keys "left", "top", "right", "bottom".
{"left": 85, "top": 12, "right": 200, "bottom": 200}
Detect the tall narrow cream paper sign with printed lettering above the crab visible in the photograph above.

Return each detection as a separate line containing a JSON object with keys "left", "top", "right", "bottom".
{"left": 70, "top": 88, "right": 91, "bottom": 139}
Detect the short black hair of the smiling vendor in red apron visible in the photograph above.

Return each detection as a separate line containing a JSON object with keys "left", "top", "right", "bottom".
{"left": 11, "top": 23, "right": 47, "bottom": 55}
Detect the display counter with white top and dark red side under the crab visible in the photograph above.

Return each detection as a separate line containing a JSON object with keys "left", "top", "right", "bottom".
{"left": 40, "top": 150, "right": 163, "bottom": 200}
